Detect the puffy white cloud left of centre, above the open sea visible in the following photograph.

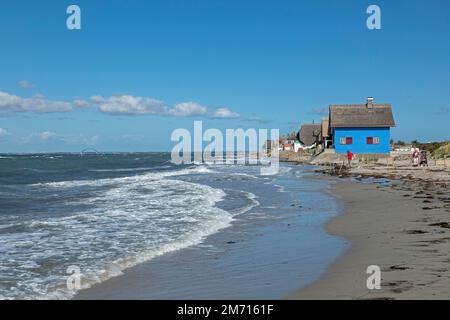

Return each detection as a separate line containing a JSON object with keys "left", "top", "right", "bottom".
{"left": 91, "top": 95, "right": 167, "bottom": 115}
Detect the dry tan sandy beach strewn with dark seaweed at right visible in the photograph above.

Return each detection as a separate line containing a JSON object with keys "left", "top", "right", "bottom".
{"left": 288, "top": 168, "right": 450, "bottom": 299}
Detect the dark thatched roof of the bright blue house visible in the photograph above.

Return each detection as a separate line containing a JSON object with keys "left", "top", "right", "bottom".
{"left": 330, "top": 104, "right": 395, "bottom": 128}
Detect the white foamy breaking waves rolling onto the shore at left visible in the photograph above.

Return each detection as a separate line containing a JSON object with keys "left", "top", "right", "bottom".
{"left": 0, "top": 166, "right": 232, "bottom": 299}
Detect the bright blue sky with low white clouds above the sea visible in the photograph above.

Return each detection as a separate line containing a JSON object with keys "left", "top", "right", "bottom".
{"left": 0, "top": 0, "right": 450, "bottom": 153}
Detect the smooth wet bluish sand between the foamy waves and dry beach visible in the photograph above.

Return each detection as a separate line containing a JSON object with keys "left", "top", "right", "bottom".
{"left": 73, "top": 168, "right": 346, "bottom": 300}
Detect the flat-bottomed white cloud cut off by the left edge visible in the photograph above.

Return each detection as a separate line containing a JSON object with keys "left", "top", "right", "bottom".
{"left": 0, "top": 91, "right": 73, "bottom": 113}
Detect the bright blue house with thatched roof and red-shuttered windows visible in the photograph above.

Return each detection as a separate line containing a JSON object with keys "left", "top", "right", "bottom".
{"left": 329, "top": 98, "right": 395, "bottom": 154}
